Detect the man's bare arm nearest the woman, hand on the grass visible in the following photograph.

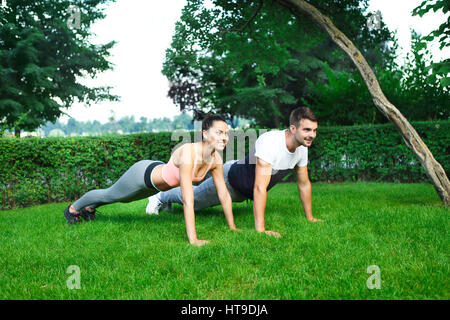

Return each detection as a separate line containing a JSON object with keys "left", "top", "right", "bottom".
{"left": 253, "top": 158, "right": 280, "bottom": 237}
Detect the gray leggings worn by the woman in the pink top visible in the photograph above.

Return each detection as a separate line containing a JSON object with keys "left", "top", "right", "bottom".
{"left": 73, "top": 160, "right": 163, "bottom": 211}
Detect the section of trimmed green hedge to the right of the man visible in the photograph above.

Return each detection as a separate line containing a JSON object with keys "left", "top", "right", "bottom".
{"left": 309, "top": 121, "right": 450, "bottom": 182}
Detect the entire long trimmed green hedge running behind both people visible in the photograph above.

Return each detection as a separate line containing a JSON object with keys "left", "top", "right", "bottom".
{"left": 0, "top": 121, "right": 450, "bottom": 209}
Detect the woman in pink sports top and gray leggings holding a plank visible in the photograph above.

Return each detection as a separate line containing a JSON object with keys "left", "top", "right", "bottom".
{"left": 64, "top": 116, "right": 237, "bottom": 246}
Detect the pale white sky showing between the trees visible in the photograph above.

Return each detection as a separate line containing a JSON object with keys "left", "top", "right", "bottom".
{"left": 60, "top": 0, "right": 450, "bottom": 123}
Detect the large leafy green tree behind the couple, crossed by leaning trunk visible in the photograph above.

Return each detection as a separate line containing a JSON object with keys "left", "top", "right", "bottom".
{"left": 163, "top": 0, "right": 392, "bottom": 127}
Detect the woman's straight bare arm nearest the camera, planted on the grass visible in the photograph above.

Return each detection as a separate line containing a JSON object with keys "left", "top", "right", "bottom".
{"left": 179, "top": 147, "right": 209, "bottom": 246}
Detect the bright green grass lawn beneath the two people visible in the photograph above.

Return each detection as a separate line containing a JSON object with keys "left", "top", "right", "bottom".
{"left": 0, "top": 183, "right": 449, "bottom": 299}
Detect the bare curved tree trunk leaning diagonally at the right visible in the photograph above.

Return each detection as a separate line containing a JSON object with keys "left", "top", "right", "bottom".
{"left": 276, "top": 0, "right": 450, "bottom": 206}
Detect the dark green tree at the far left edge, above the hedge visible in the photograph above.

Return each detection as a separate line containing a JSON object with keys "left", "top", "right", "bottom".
{"left": 0, "top": 0, "right": 118, "bottom": 135}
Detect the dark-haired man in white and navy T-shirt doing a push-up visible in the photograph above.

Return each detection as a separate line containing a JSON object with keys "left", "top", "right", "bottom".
{"left": 146, "top": 107, "right": 322, "bottom": 237}
